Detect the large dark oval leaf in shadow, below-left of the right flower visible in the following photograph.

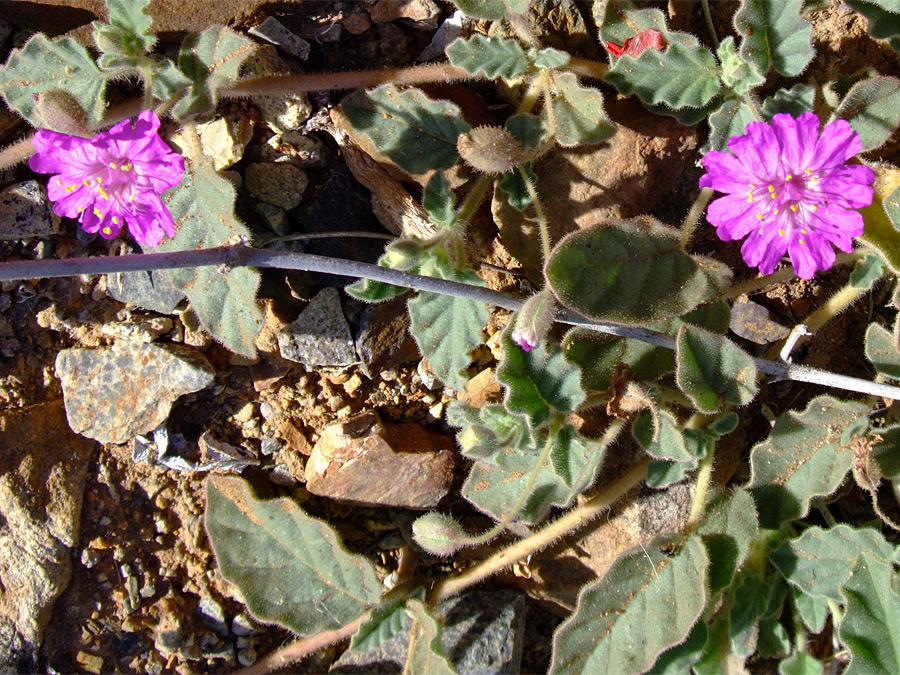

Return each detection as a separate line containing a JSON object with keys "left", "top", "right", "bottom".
{"left": 546, "top": 220, "right": 731, "bottom": 324}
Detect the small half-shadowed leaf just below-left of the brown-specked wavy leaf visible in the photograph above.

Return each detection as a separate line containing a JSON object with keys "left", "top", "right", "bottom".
{"left": 697, "top": 489, "right": 759, "bottom": 594}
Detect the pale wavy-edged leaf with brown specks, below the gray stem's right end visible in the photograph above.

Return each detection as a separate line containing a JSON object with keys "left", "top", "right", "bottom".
{"left": 748, "top": 396, "right": 870, "bottom": 530}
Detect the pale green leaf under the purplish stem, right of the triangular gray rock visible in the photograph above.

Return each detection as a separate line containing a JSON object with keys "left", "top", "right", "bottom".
{"left": 408, "top": 268, "right": 490, "bottom": 389}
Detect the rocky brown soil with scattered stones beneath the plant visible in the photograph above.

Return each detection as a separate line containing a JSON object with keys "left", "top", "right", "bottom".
{"left": 0, "top": 0, "right": 896, "bottom": 673}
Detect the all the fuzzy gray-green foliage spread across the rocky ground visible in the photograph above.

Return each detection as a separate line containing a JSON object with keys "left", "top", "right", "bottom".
{"left": 0, "top": 0, "right": 900, "bottom": 673}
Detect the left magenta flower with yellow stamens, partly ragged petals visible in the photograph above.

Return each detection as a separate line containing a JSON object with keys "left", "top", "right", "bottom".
{"left": 28, "top": 110, "right": 184, "bottom": 246}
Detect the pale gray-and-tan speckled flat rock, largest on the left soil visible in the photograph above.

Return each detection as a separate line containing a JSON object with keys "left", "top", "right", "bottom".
{"left": 56, "top": 342, "right": 214, "bottom": 443}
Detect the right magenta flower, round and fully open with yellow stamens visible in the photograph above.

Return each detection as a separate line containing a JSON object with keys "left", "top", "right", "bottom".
{"left": 700, "top": 113, "right": 875, "bottom": 279}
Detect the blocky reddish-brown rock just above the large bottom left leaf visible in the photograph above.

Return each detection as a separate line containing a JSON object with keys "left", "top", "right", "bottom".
{"left": 306, "top": 413, "right": 456, "bottom": 509}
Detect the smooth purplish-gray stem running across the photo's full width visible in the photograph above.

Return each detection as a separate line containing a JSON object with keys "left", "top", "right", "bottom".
{"left": 0, "top": 245, "right": 900, "bottom": 400}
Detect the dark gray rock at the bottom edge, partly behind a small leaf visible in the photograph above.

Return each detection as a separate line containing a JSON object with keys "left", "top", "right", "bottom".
{"left": 329, "top": 590, "right": 526, "bottom": 675}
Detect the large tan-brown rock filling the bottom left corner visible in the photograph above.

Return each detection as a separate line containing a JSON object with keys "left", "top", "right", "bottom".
{"left": 0, "top": 401, "right": 96, "bottom": 672}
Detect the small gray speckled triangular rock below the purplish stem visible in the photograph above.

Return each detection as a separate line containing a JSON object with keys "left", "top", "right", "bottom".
{"left": 278, "top": 287, "right": 357, "bottom": 367}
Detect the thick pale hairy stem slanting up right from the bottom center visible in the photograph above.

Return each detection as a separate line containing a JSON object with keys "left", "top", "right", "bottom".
{"left": 430, "top": 420, "right": 632, "bottom": 605}
